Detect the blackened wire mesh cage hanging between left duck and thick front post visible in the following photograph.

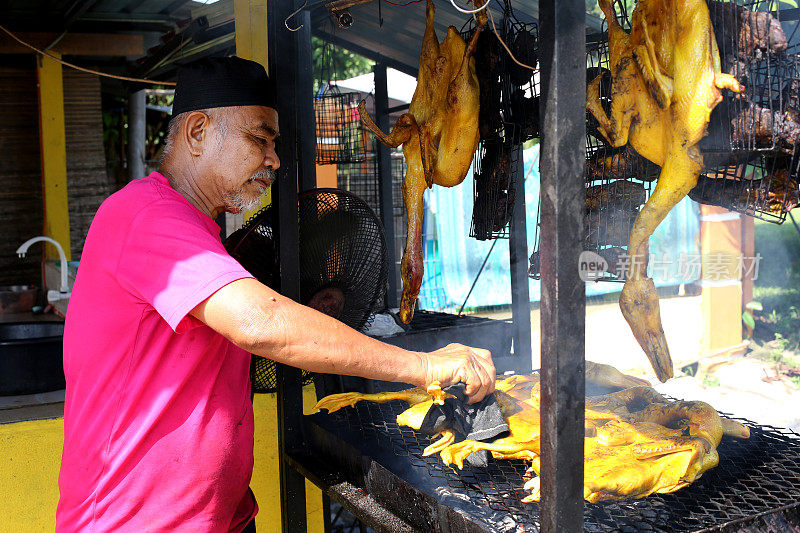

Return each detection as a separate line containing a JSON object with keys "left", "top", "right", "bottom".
{"left": 462, "top": 7, "right": 540, "bottom": 240}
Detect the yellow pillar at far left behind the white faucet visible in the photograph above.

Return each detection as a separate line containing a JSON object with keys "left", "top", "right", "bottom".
{"left": 36, "top": 53, "right": 72, "bottom": 261}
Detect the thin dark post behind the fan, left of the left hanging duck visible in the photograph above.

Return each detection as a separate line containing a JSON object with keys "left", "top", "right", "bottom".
{"left": 374, "top": 63, "right": 399, "bottom": 307}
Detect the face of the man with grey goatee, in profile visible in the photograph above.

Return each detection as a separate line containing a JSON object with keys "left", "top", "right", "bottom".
{"left": 209, "top": 106, "right": 280, "bottom": 213}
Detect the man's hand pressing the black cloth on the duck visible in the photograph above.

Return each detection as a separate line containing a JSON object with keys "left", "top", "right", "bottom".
{"left": 422, "top": 344, "right": 495, "bottom": 403}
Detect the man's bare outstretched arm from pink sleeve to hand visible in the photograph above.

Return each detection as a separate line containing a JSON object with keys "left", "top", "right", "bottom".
{"left": 191, "top": 278, "right": 495, "bottom": 401}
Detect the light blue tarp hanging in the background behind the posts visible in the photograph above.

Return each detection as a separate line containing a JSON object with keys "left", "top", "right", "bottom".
{"left": 420, "top": 145, "right": 700, "bottom": 309}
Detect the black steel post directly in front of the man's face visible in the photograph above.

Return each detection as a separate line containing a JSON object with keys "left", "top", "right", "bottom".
{"left": 267, "top": 0, "right": 315, "bottom": 533}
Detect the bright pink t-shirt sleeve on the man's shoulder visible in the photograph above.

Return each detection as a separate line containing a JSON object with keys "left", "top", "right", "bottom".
{"left": 116, "top": 201, "right": 253, "bottom": 331}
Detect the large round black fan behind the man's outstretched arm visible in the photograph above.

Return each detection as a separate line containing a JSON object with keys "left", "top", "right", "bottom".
{"left": 225, "top": 189, "right": 388, "bottom": 393}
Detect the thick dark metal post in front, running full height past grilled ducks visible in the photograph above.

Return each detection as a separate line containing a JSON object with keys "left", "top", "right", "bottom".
{"left": 539, "top": 0, "right": 586, "bottom": 533}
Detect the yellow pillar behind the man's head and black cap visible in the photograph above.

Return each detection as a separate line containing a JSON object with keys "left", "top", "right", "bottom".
{"left": 233, "top": 0, "right": 272, "bottom": 221}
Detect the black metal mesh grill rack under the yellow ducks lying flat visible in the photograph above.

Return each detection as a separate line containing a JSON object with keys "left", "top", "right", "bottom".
{"left": 306, "top": 401, "right": 800, "bottom": 532}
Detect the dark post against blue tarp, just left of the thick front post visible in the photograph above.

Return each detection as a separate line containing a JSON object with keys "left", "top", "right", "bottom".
{"left": 510, "top": 152, "right": 533, "bottom": 374}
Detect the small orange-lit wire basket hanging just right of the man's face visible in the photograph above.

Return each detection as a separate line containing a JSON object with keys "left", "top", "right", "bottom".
{"left": 314, "top": 84, "right": 370, "bottom": 165}
